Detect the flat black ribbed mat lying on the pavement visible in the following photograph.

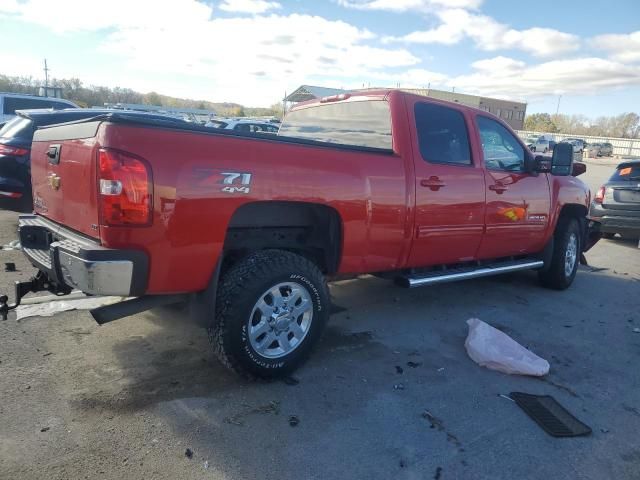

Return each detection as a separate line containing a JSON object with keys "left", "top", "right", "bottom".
{"left": 509, "top": 392, "right": 591, "bottom": 437}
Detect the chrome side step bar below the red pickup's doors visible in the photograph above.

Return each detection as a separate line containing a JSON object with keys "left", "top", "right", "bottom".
{"left": 396, "top": 258, "right": 544, "bottom": 288}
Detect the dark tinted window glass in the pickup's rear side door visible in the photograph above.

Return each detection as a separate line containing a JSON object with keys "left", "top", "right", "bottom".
{"left": 415, "top": 103, "right": 471, "bottom": 165}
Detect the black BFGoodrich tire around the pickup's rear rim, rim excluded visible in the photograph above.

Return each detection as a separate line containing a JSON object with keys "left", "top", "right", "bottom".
{"left": 207, "top": 250, "right": 330, "bottom": 378}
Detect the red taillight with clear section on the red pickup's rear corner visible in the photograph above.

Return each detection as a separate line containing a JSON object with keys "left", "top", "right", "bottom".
{"left": 98, "top": 148, "right": 153, "bottom": 226}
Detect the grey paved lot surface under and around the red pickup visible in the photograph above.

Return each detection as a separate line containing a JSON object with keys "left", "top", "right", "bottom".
{"left": 0, "top": 165, "right": 640, "bottom": 480}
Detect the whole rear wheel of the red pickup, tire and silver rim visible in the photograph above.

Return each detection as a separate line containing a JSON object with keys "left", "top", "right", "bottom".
{"left": 208, "top": 250, "right": 329, "bottom": 378}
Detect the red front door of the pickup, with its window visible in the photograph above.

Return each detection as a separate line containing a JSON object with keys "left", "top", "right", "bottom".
{"left": 475, "top": 115, "right": 551, "bottom": 259}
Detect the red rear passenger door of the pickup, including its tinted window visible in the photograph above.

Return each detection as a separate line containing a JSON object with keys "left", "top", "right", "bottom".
{"left": 407, "top": 97, "right": 485, "bottom": 267}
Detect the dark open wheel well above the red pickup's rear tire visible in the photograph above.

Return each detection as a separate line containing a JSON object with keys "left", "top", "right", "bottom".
{"left": 223, "top": 201, "right": 342, "bottom": 274}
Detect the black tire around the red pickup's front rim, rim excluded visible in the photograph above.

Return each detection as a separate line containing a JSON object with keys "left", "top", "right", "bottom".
{"left": 538, "top": 217, "right": 582, "bottom": 290}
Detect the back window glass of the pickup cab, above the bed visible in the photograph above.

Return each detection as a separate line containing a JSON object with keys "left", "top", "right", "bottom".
{"left": 278, "top": 100, "right": 392, "bottom": 150}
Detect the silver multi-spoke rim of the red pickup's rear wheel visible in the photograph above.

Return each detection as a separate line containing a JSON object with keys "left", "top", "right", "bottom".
{"left": 248, "top": 282, "right": 313, "bottom": 358}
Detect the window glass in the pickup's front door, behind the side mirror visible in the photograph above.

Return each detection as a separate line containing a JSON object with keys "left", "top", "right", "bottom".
{"left": 476, "top": 115, "right": 525, "bottom": 172}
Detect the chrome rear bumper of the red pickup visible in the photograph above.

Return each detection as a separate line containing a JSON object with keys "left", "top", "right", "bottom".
{"left": 18, "top": 215, "right": 149, "bottom": 296}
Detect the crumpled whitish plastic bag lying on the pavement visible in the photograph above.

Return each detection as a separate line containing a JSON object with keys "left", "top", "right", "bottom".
{"left": 464, "top": 318, "right": 549, "bottom": 377}
